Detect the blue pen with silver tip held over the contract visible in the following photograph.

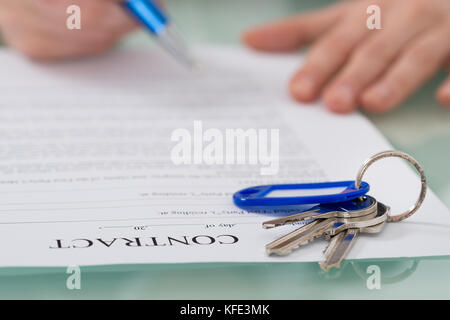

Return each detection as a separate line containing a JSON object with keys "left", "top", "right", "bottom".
{"left": 123, "top": 0, "right": 195, "bottom": 68}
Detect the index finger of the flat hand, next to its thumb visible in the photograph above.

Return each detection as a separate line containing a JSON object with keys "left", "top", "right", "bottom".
{"left": 290, "top": 4, "right": 369, "bottom": 102}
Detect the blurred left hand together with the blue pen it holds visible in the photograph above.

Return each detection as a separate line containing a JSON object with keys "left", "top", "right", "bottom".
{"left": 0, "top": 0, "right": 193, "bottom": 65}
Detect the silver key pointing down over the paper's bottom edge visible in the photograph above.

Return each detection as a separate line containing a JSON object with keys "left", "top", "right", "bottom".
{"left": 319, "top": 202, "right": 390, "bottom": 271}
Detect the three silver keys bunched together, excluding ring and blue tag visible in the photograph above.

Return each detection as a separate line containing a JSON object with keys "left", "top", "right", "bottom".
{"left": 263, "top": 196, "right": 390, "bottom": 271}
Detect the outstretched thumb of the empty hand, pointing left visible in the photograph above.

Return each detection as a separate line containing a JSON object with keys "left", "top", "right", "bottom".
{"left": 242, "top": 3, "right": 348, "bottom": 51}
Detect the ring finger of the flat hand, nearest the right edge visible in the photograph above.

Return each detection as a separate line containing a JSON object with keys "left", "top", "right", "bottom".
{"left": 361, "top": 23, "right": 450, "bottom": 112}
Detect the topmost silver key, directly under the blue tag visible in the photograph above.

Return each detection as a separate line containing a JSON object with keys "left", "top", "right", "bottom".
{"left": 263, "top": 196, "right": 377, "bottom": 229}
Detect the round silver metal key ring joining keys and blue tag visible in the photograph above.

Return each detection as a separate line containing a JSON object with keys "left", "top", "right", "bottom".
{"left": 355, "top": 151, "right": 427, "bottom": 222}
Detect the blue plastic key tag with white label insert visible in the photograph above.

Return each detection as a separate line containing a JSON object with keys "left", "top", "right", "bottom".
{"left": 233, "top": 180, "right": 370, "bottom": 208}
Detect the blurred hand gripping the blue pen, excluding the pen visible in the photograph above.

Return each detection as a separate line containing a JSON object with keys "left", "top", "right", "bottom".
{"left": 0, "top": 0, "right": 136, "bottom": 60}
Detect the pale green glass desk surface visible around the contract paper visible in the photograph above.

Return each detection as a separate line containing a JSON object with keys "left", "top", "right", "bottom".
{"left": 0, "top": 0, "right": 450, "bottom": 299}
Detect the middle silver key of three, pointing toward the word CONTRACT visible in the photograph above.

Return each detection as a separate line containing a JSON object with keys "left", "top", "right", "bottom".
{"left": 266, "top": 200, "right": 388, "bottom": 255}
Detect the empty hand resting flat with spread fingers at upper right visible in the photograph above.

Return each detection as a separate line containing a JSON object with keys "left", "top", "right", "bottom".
{"left": 243, "top": 0, "right": 450, "bottom": 113}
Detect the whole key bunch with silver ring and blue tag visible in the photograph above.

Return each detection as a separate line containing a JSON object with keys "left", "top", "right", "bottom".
{"left": 233, "top": 151, "right": 427, "bottom": 271}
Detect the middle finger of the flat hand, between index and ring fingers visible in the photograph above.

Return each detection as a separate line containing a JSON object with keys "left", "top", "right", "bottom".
{"left": 323, "top": 0, "right": 434, "bottom": 113}
